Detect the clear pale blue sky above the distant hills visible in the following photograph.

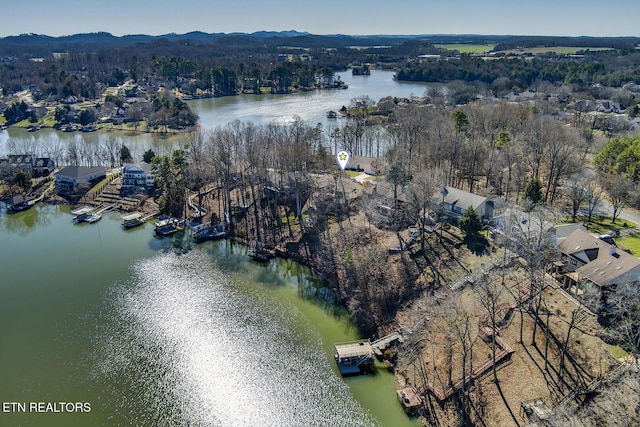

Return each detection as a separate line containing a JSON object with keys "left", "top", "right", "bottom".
{"left": 0, "top": 0, "right": 640, "bottom": 37}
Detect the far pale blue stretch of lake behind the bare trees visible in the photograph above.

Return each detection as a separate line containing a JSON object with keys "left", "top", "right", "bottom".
{"left": 0, "top": 70, "right": 429, "bottom": 158}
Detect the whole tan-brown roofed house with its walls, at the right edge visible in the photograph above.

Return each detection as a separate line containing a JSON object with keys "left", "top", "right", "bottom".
{"left": 554, "top": 230, "right": 640, "bottom": 310}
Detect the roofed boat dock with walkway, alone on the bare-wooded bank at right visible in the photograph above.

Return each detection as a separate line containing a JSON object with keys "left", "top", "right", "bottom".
{"left": 333, "top": 332, "right": 402, "bottom": 376}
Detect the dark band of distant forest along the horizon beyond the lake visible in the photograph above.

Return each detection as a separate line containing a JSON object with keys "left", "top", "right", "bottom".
{"left": 0, "top": 35, "right": 640, "bottom": 100}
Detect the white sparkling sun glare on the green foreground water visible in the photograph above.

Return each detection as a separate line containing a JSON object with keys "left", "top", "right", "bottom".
{"left": 94, "top": 250, "right": 375, "bottom": 426}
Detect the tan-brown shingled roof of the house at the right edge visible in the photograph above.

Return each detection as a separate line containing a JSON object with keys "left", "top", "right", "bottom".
{"left": 558, "top": 230, "right": 640, "bottom": 286}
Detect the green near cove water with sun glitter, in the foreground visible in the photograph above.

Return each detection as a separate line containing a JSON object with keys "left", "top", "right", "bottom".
{"left": 0, "top": 206, "right": 415, "bottom": 426}
